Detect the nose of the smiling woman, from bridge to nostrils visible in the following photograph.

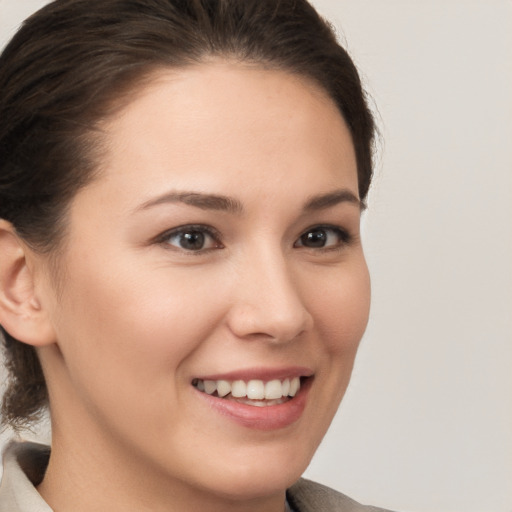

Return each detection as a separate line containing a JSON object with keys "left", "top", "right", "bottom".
{"left": 228, "top": 249, "right": 313, "bottom": 343}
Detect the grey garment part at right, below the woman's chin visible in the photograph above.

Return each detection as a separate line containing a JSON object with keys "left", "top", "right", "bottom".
{"left": 287, "top": 478, "right": 394, "bottom": 512}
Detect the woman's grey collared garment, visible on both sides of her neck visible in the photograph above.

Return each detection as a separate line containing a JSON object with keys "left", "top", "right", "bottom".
{"left": 0, "top": 442, "right": 394, "bottom": 512}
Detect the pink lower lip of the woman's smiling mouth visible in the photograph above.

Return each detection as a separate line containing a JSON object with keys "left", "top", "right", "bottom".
{"left": 197, "top": 377, "right": 313, "bottom": 430}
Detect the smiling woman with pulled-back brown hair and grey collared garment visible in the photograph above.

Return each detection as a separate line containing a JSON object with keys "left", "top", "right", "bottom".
{"left": 0, "top": 0, "right": 388, "bottom": 512}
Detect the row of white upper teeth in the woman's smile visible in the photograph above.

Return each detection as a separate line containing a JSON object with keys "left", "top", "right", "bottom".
{"left": 194, "top": 377, "right": 300, "bottom": 405}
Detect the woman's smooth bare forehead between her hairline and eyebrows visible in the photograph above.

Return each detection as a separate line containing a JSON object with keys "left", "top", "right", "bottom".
{"left": 85, "top": 61, "right": 357, "bottom": 208}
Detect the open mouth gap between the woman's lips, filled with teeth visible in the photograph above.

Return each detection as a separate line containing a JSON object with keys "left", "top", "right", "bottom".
{"left": 192, "top": 377, "right": 307, "bottom": 407}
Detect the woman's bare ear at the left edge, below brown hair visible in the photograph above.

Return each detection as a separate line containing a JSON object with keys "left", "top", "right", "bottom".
{"left": 0, "top": 219, "right": 55, "bottom": 347}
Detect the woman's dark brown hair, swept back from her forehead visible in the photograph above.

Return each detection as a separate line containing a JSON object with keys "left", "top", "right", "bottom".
{"left": 0, "top": 0, "right": 374, "bottom": 427}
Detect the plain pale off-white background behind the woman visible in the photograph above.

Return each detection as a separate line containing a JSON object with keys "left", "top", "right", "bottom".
{"left": 0, "top": 0, "right": 512, "bottom": 512}
